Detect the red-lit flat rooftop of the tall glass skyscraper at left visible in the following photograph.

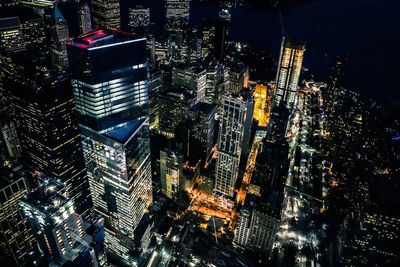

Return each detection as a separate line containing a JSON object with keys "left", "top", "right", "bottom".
{"left": 68, "top": 29, "right": 144, "bottom": 49}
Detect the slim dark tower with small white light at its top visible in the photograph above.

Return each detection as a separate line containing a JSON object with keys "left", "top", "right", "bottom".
{"left": 214, "top": 9, "right": 231, "bottom": 61}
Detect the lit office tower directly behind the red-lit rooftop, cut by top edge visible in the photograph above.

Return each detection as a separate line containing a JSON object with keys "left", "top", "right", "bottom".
{"left": 90, "top": 0, "right": 121, "bottom": 29}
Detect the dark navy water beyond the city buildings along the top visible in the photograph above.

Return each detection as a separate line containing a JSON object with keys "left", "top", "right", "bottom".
{"left": 122, "top": 0, "right": 400, "bottom": 108}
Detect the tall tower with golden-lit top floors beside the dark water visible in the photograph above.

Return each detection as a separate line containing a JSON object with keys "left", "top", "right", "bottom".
{"left": 274, "top": 37, "right": 305, "bottom": 111}
